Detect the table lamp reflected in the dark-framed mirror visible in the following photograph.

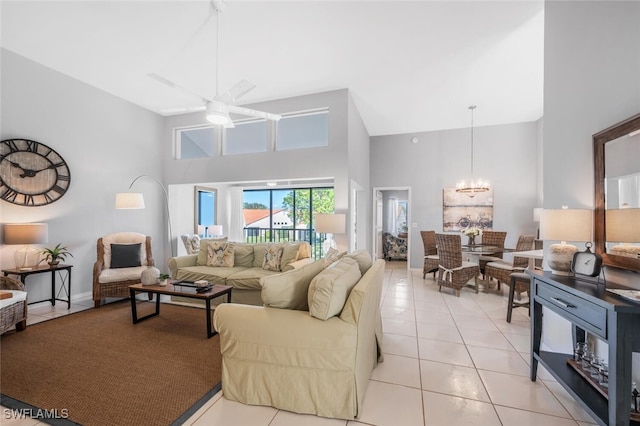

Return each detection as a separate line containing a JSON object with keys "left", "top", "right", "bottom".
{"left": 605, "top": 209, "right": 640, "bottom": 259}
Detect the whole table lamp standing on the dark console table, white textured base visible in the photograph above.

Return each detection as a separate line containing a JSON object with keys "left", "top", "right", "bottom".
{"left": 540, "top": 207, "right": 593, "bottom": 276}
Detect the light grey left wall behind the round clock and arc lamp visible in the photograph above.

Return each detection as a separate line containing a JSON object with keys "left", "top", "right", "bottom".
{"left": 0, "top": 49, "right": 168, "bottom": 300}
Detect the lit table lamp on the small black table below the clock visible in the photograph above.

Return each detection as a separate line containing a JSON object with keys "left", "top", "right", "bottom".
{"left": 3, "top": 223, "right": 49, "bottom": 271}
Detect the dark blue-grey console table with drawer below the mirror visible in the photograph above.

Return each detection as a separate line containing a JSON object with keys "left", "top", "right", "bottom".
{"left": 528, "top": 271, "right": 640, "bottom": 426}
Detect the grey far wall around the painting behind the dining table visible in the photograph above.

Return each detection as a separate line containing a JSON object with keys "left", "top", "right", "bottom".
{"left": 370, "top": 122, "right": 540, "bottom": 268}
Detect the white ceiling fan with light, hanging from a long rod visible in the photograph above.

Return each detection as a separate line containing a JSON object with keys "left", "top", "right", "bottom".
{"left": 148, "top": 0, "right": 281, "bottom": 127}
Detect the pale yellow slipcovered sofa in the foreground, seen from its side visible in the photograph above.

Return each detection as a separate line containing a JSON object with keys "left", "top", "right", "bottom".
{"left": 214, "top": 255, "right": 385, "bottom": 419}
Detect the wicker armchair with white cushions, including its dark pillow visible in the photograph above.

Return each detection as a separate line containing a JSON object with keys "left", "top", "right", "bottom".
{"left": 93, "top": 232, "right": 154, "bottom": 308}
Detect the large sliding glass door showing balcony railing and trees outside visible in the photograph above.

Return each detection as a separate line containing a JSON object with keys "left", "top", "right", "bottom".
{"left": 243, "top": 188, "right": 334, "bottom": 258}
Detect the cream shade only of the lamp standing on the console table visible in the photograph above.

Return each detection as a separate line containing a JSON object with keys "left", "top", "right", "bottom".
{"left": 540, "top": 209, "right": 593, "bottom": 241}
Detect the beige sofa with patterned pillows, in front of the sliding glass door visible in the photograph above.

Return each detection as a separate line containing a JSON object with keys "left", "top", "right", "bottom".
{"left": 168, "top": 238, "right": 313, "bottom": 305}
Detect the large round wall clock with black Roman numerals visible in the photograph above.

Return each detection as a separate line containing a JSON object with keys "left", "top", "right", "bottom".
{"left": 0, "top": 139, "right": 71, "bottom": 206}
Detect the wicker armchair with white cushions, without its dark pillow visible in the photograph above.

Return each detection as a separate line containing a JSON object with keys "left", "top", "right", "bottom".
{"left": 93, "top": 232, "right": 154, "bottom": 308}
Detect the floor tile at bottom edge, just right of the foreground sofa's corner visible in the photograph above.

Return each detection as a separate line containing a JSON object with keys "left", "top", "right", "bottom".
{"left": 358, "top": 380, "right": 424, "bottom": 426}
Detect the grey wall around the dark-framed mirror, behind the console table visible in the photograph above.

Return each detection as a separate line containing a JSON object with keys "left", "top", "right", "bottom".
{"left": 543, "top": 1, "right": 640, "bottom": 381}
